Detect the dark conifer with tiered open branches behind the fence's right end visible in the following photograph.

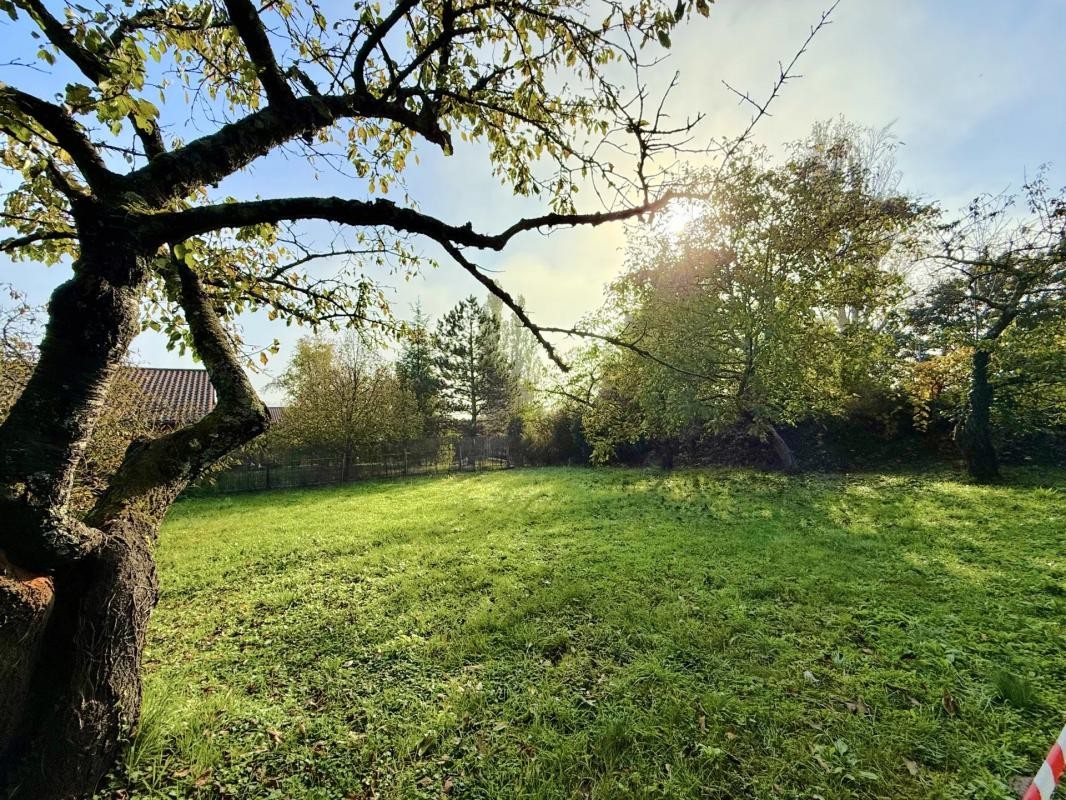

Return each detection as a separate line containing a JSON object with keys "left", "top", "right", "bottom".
{"left": 435, "top": 295, "right": 515, "bottom": 436}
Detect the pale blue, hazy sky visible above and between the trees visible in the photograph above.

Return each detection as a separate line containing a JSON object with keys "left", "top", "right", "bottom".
{"left": 0, "top": 0, "right": 1066, "bottom": 401}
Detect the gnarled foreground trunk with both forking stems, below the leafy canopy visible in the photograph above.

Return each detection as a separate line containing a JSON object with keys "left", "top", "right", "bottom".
{"left": 0, "top": 247, "right": 268, "bottom": 800}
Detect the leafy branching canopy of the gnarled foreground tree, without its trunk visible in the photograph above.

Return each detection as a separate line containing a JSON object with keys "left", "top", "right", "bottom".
{"left": 6, "top": 0, "right": 709, "bottom": 360}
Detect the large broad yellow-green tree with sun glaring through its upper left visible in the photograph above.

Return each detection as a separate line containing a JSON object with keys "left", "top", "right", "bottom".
{"left": 589, "top": 125, "right": 923, "bottom": 469}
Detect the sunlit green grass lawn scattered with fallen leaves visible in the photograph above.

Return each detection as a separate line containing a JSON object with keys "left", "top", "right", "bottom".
{"left": 104, "top": 469, "right": 1066, "bottom": 800}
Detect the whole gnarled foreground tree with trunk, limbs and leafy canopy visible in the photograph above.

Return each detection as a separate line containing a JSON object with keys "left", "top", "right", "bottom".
{"left": 0, "top": 0, "right": 708, "bottom": 798}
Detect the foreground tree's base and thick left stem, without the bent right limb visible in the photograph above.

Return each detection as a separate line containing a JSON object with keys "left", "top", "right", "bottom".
{"left": 0, "top": 233, "right": 155, "bottom": 798}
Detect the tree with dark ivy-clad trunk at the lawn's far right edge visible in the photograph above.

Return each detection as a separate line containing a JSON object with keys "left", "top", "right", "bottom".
{"left": 910, "top": 175, "right": 1066, "bottom": 481}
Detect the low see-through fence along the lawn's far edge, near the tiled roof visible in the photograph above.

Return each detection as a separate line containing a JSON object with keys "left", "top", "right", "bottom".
{"left": 191, "top": 436, "right": 512, "bottom": 494}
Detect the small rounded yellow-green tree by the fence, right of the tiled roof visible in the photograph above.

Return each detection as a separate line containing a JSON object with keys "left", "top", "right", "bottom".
{"left": 278, "top": 334, "right": 422, "bottom": 480}
